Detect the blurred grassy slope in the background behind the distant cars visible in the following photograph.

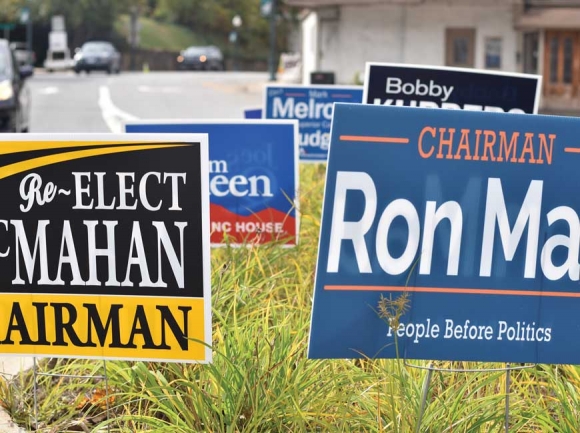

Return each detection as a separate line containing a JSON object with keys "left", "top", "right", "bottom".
{"left": 115, "top": 15, "right": 210, "bottom": 51}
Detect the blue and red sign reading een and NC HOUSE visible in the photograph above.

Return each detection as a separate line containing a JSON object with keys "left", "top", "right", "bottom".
{"left": 125, "top": 120, "right": 299, "bottom": 246}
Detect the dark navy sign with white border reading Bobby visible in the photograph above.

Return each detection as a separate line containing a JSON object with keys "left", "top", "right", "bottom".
{"left": 363, "top": 62, "right": 542, "bottom": 114}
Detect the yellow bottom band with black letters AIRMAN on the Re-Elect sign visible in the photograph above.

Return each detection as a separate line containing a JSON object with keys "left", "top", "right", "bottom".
{"left": 0, "top": 295, "right": 204, "bottom": 359}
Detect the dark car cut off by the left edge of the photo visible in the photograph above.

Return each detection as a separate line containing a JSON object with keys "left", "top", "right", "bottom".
{"left": 0, "top": 39, "right": 34, "bottom": 132}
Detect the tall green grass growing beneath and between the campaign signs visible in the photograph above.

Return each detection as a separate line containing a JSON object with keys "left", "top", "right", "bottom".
{"left": 0, "top": 165, "right": 580, "bottom": 433}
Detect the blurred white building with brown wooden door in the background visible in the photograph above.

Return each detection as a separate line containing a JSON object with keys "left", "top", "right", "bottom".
{"left": 286, "top": 0, "right": 580, "bottom": 109}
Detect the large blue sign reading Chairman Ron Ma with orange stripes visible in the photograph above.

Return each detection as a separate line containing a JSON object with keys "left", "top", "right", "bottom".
{"left": 308, "top": 104, "right": 580, "bottom": 364}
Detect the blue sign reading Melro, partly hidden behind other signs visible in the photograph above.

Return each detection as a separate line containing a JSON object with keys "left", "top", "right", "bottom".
{"left": 264, "top": 85, "right": 363, "bottom": 162}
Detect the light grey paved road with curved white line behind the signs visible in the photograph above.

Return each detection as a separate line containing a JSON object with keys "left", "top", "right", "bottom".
{"left": 0, "top": 72, "right": 268, "bottom": 382}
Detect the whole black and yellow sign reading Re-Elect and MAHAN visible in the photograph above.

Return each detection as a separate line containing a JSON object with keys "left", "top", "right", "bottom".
{"left": 0, "top": 134, "right": 211, "bottom": 363}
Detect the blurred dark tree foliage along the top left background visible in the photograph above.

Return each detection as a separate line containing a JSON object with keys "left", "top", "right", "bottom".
{"left": 0, "top": 0, "right": 288, "bottom": 57}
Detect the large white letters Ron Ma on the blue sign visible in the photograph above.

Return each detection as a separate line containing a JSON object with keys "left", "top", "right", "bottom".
{"left": 326, "top": 171, "right": 580, "bottom": 281}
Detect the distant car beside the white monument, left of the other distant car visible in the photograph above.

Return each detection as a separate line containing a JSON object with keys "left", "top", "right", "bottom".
{"left": 73, "top": 41, "right": 121, "bottom": 74}
